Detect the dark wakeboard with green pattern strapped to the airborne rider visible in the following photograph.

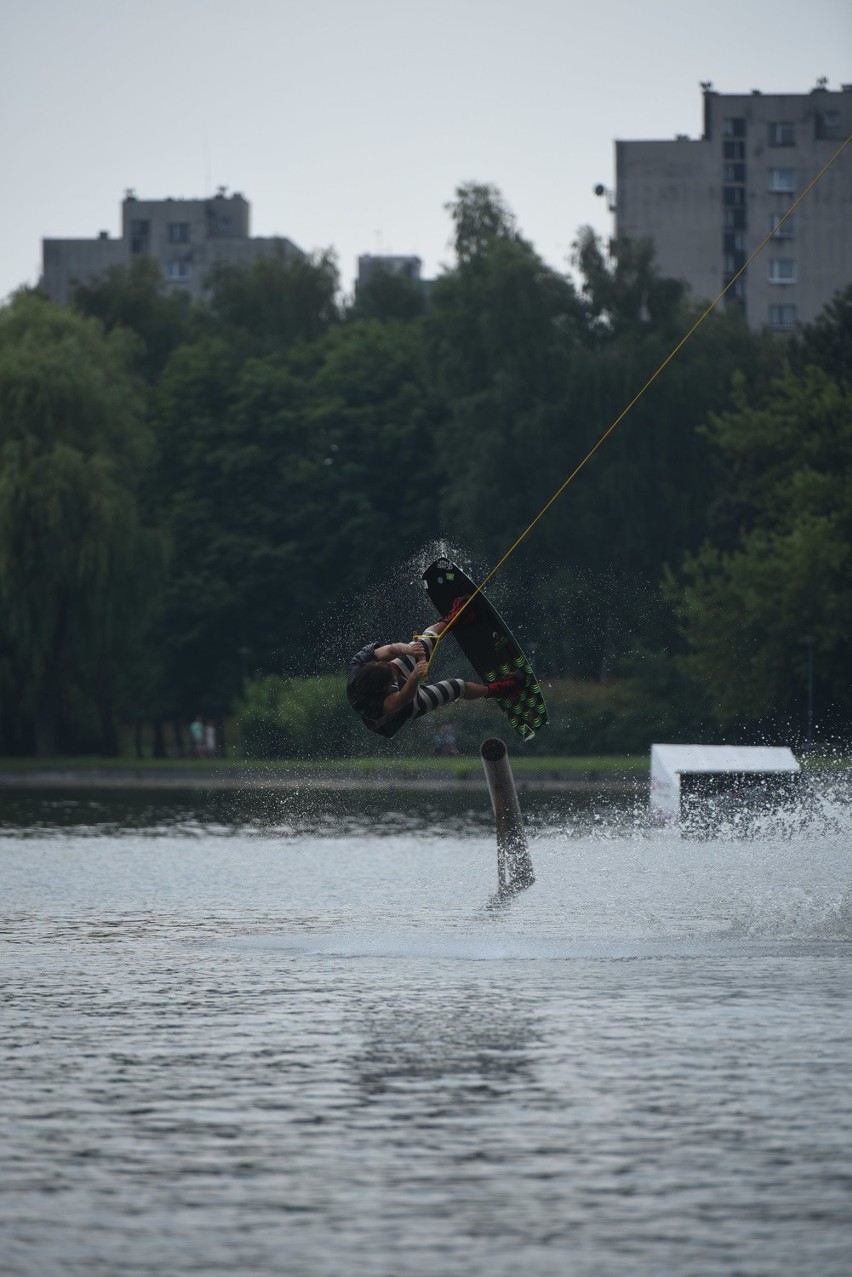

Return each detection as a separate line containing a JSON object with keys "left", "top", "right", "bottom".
{"left": 423, "top": 558, "right": 547, "bottom": 741}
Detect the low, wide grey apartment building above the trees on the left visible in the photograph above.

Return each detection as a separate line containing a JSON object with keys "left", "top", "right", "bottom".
{"left": 41, "top": 188, "right": 304, "bottom": 304}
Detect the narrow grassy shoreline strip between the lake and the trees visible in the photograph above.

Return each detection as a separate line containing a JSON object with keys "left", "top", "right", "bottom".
{"left": 0, "top": 759, "right": 649, "bottom": 793}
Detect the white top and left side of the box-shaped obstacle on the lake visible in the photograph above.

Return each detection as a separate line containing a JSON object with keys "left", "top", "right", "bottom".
{"left": 650, "top": 744, "right": 800, "bottom": 821}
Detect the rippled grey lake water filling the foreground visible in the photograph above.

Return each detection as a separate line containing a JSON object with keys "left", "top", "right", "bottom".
{"left": 0, "top": 785, "right": 852, "bottom": 1277}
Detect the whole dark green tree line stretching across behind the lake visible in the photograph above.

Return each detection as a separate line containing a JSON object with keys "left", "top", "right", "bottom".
{"left": 0, "top": 185, "right": 852, "bottom": 755}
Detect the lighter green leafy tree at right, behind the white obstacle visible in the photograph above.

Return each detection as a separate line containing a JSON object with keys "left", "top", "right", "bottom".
{"left": 669, "top": 366, "right": 852, "bottom": 729}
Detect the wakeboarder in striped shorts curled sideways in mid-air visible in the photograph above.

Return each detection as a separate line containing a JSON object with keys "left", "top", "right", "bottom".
{"left": 346, "top": 598, "right": 525, "bottom": 737}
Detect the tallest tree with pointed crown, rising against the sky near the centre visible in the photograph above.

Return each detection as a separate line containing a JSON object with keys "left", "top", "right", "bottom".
{"left": 429, "top": 186, "right": 581, "bottom": 559}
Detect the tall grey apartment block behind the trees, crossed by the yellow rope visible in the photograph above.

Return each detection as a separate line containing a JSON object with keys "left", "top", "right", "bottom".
{"left": 613, "top": 82, "right": 852, "bottom": 331}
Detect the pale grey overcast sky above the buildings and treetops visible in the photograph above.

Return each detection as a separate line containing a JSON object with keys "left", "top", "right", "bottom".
{"left": 0, "top": 0, "right": 852, "bottom": 299}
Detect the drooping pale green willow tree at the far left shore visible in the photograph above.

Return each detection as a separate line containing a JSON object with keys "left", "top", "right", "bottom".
{"left": 0, "top": 292, "right": 160, "bottom": 755}
